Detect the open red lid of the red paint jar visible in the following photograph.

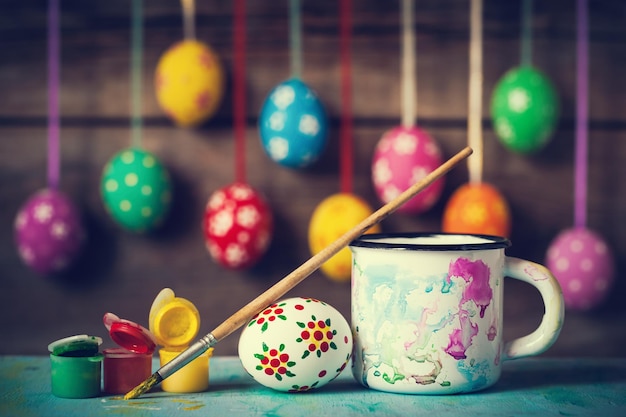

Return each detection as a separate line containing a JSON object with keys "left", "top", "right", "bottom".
{"left": 102, "top": 313, "right": 156, "bottom": 354}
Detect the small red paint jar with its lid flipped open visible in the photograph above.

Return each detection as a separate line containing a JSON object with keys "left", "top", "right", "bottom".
{"left": 103, "top": 313, "right": 156, "bottom": 394}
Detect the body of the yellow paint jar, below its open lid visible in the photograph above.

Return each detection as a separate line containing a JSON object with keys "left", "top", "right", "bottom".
{"left": 159, "top": 348, "right": 213, "bottom": 393}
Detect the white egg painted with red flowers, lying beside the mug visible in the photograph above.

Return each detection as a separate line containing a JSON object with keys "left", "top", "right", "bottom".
{"left": 238, "top": 297, "right": 352, "bottom": 392}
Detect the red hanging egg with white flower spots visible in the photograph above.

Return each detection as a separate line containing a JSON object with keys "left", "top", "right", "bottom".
{"left": 202, "top": 182, "right": 273, "bottom": 269}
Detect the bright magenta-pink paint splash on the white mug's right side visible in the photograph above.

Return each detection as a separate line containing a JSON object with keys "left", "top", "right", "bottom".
{"left": 445, "top": 258, "right": 493, "bottom": 360}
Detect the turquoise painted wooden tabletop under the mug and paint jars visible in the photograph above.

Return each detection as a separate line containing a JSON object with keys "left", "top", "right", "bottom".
{"left": 0, "top": 356, "right": 626, "bottom": 417}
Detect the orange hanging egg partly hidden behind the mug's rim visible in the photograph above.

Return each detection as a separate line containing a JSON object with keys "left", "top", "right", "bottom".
{"left": 442, "top": 183, "right": 511, "bottom": 237}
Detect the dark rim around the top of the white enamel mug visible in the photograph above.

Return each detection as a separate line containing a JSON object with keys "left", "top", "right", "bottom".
{"left": 348, "top": 232, "right": 511, "bottom": 252}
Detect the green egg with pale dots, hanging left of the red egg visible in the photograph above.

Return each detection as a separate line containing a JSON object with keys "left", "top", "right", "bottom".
{"left": 101, "top": 148, "right": 172, "bottom": 233}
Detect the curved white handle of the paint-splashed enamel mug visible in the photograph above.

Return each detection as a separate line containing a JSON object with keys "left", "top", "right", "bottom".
{"left": 503, "top": 256, "right": 565, "bottom": 360}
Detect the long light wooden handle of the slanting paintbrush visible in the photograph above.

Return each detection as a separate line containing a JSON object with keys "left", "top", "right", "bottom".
{"left": 211, "top": 147, "right": 472, "bottom": 341}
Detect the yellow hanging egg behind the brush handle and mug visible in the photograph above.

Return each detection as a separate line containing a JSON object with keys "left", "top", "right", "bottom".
{"left": 309, "top": 193, "right": 380, "bottom": 281}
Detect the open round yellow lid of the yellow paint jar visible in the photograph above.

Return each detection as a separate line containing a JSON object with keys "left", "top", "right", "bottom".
{"left": 150, "top": 288, "right": 200, "bottom": 347}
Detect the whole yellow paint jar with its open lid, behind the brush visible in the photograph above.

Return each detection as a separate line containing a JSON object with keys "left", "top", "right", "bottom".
{"left": 149, "top": 288, "right": 213, "bottom": 393}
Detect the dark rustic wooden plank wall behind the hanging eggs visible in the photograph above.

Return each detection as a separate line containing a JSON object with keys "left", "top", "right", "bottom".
{"left": 0, "top": 0, "right": 626, "bottom": 356}
